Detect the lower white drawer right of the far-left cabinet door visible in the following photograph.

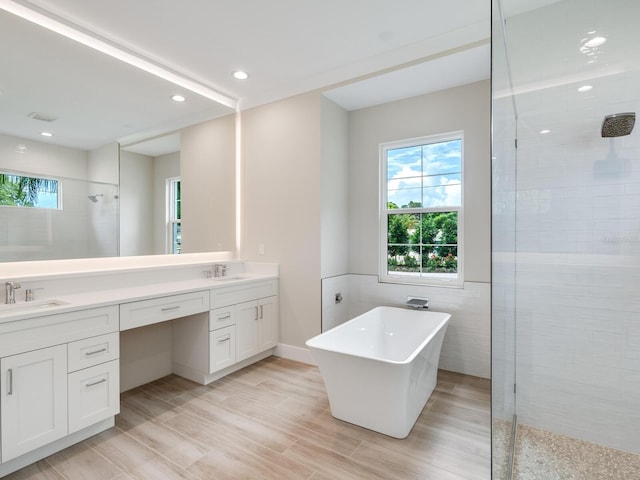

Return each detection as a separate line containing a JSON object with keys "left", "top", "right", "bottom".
{"left": 67, "top": 360, "right": 120, "bottom": 433}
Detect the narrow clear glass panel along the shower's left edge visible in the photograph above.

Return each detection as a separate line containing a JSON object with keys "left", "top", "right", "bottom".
{"left": 491, "top": 0, "right": 516, "bottom": 480}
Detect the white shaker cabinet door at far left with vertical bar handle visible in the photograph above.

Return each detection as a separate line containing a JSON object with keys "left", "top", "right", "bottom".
{"left": 0, "top": 344, "right": 67, "bottom": 462}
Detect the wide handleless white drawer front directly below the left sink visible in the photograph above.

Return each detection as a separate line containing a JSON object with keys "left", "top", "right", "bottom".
{"left": 0, "top": 305, "right": 118, "bottom": 356}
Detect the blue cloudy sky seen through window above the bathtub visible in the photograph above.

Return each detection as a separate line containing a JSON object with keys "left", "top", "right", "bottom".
{"left": 387, "top": 140, "right": 462, "bottom": 207}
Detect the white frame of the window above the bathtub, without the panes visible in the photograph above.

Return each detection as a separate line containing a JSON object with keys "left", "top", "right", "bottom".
{"left": 378, "top": 131, "right": 465, "bottom": 288}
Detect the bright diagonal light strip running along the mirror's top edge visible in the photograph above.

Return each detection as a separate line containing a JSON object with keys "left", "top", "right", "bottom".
{"left": 0, "top": 0, "right": 238, "bottom": 110}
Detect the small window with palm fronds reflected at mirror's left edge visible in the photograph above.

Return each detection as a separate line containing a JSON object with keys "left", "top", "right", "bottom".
{"left": 0, "top": 172, "right": 61, "bottom": 209}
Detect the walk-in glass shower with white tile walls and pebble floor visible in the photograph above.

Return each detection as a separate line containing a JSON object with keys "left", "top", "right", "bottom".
{"left": 492, "top": 0, "right": 640, "bottom": 480}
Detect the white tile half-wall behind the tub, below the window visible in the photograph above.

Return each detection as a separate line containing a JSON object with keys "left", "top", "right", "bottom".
{"left": 322, "top": 275, "right": 491, "bottom": 378}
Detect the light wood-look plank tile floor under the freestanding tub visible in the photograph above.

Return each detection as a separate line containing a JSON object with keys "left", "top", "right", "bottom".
{"left": 4, "top": 357, "right": 491, "bottom": 480}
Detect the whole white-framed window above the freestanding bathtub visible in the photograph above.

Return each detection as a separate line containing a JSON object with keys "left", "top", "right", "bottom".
{"left": 380, "top": 132, "right": 463, "bottom": 285}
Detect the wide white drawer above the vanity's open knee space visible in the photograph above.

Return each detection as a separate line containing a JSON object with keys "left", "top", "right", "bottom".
{"left": 120, "top": 290, "right": 209, "bottom": 330}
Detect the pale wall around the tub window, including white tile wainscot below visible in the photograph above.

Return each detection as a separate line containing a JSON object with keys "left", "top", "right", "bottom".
{"left": 241, "top": 82, "right": 490, "bottom": 377}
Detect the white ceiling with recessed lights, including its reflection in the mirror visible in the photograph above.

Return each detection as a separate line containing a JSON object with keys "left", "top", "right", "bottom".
{"left": 0, "top": 0, "right": 491, "bottom": 154}
